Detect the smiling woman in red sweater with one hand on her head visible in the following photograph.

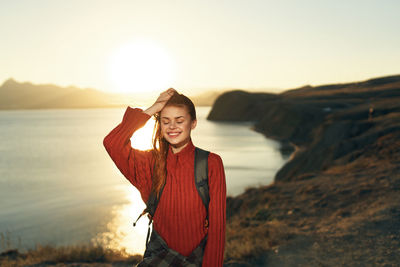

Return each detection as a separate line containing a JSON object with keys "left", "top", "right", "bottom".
{"left": 103, "top": 88, "right": 226, "bottom": 267}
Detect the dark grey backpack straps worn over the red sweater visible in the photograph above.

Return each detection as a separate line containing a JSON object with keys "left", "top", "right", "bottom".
{"left": 133, "top": 147, "right": 210, "bottom": 260}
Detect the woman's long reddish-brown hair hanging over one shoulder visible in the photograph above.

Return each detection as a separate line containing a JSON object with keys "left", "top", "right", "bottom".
{"left": 151, "top": 92, "right": 196, "bottom": 198}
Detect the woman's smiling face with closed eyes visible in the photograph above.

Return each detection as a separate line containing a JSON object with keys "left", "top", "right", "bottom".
{"left": 160, "top": 106, "right": 197, "bottom": 150}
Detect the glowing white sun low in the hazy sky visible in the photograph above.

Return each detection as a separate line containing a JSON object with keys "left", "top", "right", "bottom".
{"left": 109, "top": 40, "right": 175, "bottom": 93}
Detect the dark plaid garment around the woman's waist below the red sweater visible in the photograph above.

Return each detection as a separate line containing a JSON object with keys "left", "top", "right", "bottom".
{"left": 135, "top": 229, "right": 207, "bottom": 267}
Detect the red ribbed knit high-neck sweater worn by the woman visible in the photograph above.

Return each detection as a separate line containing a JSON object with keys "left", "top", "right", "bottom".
{"left": 103, "top": 106, "right": 226, "bottom": 267}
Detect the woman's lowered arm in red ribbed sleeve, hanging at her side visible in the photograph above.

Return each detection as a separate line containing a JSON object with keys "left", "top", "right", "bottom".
{"left": 202, "top": 153, "right": 226, "bottom": 267}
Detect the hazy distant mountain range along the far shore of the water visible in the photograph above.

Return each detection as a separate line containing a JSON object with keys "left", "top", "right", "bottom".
{"left": 0, "top": 78, "right": 223, "bottom": 110}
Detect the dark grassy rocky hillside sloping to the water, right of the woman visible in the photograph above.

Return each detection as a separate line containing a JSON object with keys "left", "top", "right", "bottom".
{"left": 208, "top": 76, "right": 400, "bottom": 266}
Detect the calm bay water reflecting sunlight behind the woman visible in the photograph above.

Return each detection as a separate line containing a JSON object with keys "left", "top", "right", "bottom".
{"left": 0, "top": 107, "right": 287, "bottom": 253}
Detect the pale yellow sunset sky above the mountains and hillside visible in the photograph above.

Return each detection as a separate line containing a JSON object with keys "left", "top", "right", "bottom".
{"left": 0, "top": 0, "right": 400, "bottom": 95}
